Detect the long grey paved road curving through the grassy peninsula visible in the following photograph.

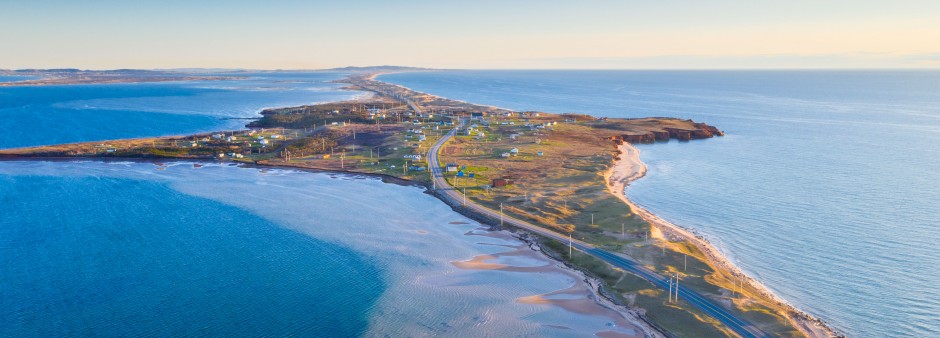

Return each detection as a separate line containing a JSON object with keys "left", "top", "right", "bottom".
{"left": 427, "top": 121, "right": 769, "bottom": 337}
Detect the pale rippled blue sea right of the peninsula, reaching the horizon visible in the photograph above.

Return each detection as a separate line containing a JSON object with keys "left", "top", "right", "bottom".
{"left": 380, "top": 71, "right": 940, "bottom": 337}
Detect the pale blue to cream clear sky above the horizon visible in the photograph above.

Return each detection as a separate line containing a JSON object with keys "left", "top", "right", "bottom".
{"left": 0, "top": 0, "right": 940, "bottom": 69}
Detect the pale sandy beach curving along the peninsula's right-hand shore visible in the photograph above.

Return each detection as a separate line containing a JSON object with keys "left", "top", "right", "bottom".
{"left": 604, "top": 142, "right": 842, "bottom": 337}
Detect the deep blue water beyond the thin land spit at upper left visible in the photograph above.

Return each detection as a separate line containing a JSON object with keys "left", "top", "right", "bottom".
{"left": 0, "top": 72, "right": 362, "bottom": 148}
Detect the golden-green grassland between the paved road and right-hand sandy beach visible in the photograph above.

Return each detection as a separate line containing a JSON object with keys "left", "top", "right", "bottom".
{"left": 441, "top": 114, "right": 802, "bottom": 337}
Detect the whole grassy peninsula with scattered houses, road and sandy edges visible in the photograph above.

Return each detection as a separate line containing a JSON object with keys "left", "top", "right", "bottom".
{"left": 0, "top": 73, "right": 834, "bottom": 337}
